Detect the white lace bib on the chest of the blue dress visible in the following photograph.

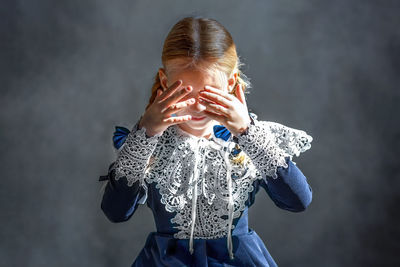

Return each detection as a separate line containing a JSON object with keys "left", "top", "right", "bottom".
{"left": 141, "top": 126, "right": 260, "bottom": 239}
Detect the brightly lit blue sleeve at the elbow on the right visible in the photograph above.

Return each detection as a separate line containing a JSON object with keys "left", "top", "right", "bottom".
{"left": 260, "top": 157, "right": 312, "bottom": 212}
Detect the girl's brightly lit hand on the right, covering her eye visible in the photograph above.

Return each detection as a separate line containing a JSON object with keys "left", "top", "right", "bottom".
{"left": 198, "top": 85, "right": 250, "bottom": 136}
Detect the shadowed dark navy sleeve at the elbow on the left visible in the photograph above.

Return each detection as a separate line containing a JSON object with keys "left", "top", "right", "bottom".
{"left": 101, "top": 162, "right": 146, "bottom": 223}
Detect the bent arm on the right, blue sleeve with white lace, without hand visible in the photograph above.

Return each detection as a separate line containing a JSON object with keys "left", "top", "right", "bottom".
{"left": 238, "top": 114, "right": 312, "bottom": 211}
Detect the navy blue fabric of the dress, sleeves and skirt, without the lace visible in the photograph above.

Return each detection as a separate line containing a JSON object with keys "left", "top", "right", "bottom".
{"left": 101, "top": 157, "right": 312, "bottom": 266}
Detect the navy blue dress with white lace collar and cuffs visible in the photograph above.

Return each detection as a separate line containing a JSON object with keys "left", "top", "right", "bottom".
{"left": 99, "top": 114, "right": 312, "bottom": 266}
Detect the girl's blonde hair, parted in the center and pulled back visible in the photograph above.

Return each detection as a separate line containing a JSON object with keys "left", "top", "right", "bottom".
{"left": 146, "top": 17, "right": 251, "bottom": 163}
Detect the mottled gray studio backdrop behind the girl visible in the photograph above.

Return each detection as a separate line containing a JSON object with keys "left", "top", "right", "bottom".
{"left": 0, "top": 0, "right": 400, "bottom": 266}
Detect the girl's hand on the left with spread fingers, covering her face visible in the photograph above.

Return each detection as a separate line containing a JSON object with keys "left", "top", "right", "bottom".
{"left": 139, "top": 80, "right": 196, "bottom": 136}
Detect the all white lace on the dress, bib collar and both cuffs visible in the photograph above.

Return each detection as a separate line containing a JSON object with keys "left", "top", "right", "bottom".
{"left": 109, "top": 118, "right": 312, "bottom": 239}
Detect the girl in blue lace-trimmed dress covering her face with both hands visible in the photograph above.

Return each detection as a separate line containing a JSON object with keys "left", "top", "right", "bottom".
{"left": 100, "top": 17, "right": 312, "bottom": 266}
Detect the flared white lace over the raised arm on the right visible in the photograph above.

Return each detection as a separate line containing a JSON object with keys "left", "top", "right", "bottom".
{"left": 238, "top": 116, "right": 313, "bottom": 179}
